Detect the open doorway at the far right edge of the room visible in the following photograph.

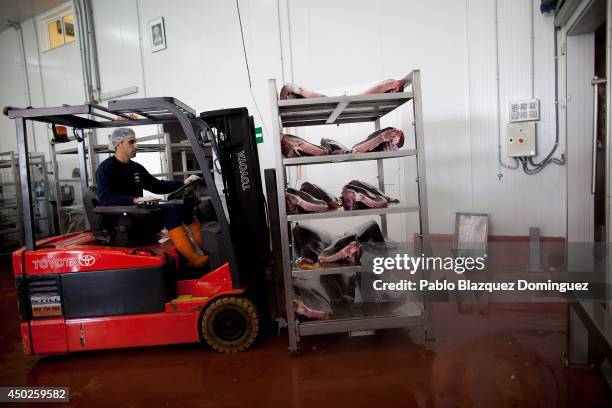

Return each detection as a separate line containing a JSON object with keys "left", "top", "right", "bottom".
{"left": 555, "top": 0, "right": 612, "bottom": 372}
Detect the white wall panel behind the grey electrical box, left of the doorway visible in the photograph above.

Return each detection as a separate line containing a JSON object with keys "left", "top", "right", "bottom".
{"left": 466, "top": 0, "right": 566, "bottom": 236}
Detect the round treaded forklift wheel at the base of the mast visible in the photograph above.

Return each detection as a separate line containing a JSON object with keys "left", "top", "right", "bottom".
{"left": 201, "top": 296, "right": 259, "bottom": 353}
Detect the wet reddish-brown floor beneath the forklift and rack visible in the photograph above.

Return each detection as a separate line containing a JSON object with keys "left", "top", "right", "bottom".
{"left": 0, "top": 258, "right": 612, "bottom": 408}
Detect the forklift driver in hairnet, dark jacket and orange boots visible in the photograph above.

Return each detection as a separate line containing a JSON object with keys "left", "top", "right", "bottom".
{"left": 96, "top": 128, "right": 208, "bottom": 268}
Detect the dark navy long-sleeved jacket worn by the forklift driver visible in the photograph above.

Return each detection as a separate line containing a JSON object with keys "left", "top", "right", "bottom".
{"left": 96, "top": 156, "right": 183, "bottom": 205}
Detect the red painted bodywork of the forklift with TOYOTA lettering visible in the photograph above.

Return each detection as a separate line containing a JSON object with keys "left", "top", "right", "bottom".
{"left": 13, "top": 232, "right": 244, "bottom": 355}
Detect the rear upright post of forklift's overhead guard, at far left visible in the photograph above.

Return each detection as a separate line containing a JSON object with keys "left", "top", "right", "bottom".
{"left": 15, "top": 118, "right": 36, "bottom": 251}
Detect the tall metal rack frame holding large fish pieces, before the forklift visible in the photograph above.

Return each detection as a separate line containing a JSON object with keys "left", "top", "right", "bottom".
{"left": 269, "top": 70, "right": 431, "bottom": 352}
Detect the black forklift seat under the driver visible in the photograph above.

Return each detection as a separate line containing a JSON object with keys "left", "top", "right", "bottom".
{"left": 83, "top": 186, "right": 163, "bottom": 247}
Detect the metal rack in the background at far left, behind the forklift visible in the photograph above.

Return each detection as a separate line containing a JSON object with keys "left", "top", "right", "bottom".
{"left": 0, "top": 151, "right": 53, "bottom": 252}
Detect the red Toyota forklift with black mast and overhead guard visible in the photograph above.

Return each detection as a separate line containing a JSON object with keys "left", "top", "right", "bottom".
{"left": 4, "top": 97, "right": 270, "bottom": 355}
